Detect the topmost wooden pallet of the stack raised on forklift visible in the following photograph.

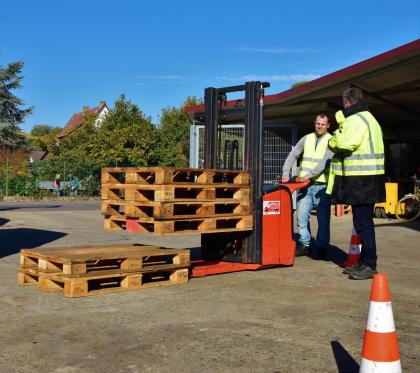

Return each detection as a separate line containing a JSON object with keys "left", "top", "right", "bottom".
{"left": 101, "top": 167, "right": 250, "bottom": 186}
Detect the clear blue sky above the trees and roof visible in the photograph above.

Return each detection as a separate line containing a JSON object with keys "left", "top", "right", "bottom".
{"left": 0, "top": 0, "right": 420, "bottom": 131}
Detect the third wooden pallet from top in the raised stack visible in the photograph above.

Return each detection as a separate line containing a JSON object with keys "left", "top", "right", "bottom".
{"left": 101, "top": 200, "right": 252, "bottom": 220}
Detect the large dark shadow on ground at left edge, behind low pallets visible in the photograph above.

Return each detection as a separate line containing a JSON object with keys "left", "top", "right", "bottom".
{"left": 0, "top": 228, "right": 67, "bottom": 258}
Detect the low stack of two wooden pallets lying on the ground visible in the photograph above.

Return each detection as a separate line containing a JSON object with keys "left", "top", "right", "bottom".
{"left": 18, "top": 245, "right": 190, "bottom": 297}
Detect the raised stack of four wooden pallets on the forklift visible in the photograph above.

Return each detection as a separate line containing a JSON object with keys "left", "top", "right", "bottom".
{"left": 101, "top": 167, "right": 253, "bottom": 234}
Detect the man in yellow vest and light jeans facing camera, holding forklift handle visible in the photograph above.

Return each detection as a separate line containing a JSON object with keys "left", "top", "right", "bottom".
{"left": 282, "top": 114, "right": 333, "bottom": 259}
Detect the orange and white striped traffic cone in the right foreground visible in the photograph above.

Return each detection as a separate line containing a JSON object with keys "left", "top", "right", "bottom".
{"left": 359, "top": 273, "right": 401, "bottom": 373}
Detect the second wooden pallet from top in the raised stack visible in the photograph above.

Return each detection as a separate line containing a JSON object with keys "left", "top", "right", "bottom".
{"left": 101, "top": 183, "right": 250, "bottom": 202}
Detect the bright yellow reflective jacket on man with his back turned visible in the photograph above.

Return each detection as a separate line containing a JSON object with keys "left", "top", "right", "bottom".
{"left": 327, "top": 111, "right": 385, "bottom": 194}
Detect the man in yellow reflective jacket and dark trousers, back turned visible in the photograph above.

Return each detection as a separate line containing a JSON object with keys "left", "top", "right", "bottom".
{"left": 327, "top": 88, "right": 385, "bottom": 280}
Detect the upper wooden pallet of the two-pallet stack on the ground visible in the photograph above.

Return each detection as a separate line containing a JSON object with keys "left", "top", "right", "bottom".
{"left": 18, "top": 246, "right": 190, "bottom": 284}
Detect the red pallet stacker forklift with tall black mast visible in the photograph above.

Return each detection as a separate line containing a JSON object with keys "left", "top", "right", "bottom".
{"left": 192, "top": 81, "right": 309, "bottom": 277}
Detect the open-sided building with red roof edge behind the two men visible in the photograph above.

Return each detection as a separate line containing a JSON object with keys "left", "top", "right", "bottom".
{"left": 184, "top": 39, "right": 420, "bottom": 183}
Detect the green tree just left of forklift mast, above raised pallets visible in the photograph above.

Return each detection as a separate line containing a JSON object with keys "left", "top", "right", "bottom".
{"left": 156, "top": 97, "right": 202, "bottom": 167}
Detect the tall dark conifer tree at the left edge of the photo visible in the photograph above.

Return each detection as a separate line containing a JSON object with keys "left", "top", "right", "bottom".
{"left": 0, "top": 61, "right": 32, "bottom": 147}
